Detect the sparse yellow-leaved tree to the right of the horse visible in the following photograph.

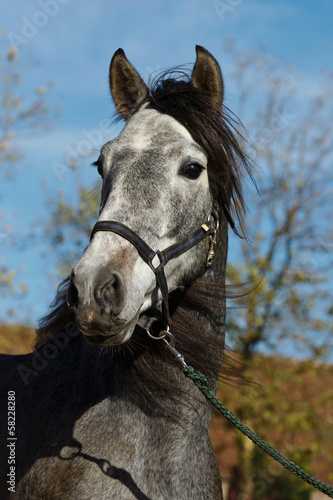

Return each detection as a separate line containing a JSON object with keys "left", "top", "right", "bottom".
{"left": 215, "top": 38, "right": 333, "bottom": 499}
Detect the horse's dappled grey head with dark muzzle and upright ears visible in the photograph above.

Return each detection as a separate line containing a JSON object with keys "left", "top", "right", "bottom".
{"left": 67, "top": 47, "right": 230, "bottom": 346}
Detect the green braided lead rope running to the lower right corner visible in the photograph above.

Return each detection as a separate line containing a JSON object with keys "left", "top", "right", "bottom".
{"left": 184, "top": 366, "right": 333, "bottom": 498}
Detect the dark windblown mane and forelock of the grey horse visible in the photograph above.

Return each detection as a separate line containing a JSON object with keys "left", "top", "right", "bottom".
{"left": 35, "top": 67, "right": 251, "bottom": 406}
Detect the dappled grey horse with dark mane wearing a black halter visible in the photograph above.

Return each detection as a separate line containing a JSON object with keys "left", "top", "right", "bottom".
{"left": 0, "top": 46, "right": 248, "bottom": 500}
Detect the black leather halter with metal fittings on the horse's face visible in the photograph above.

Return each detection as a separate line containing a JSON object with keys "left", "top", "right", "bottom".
{"left": 90, "top": 202, "right": 219, "bottom": 327}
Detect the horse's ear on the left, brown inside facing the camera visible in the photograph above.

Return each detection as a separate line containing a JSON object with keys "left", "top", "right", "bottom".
{"left": 109, "top": 49, "right": 148, "bottom": 120}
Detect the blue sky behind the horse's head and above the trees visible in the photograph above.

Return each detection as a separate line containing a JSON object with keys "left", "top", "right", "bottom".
{"left": 0, "top": 0, "right": 333, "bottom": 323}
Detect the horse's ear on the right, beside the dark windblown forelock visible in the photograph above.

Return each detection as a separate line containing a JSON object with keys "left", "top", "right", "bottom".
{"left": 191, "top": 45, "right": 223, "bottom": 107}
